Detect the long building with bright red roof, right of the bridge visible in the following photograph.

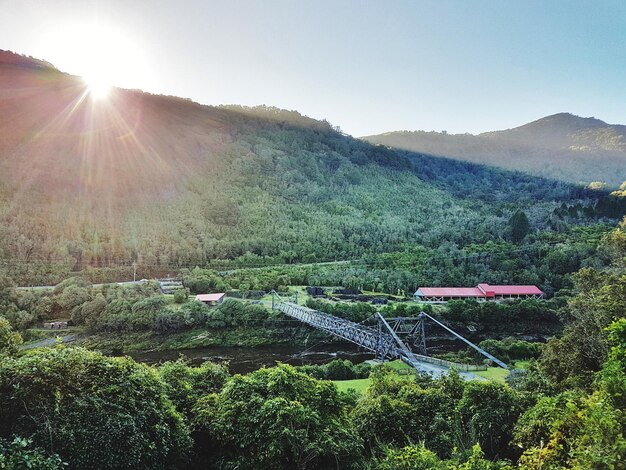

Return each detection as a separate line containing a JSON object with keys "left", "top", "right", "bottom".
{"left": 415, "top": 284, "right": 544, "bottom": 303}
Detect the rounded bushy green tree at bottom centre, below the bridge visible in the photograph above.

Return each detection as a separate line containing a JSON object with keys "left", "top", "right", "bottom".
{"left": 194, "top": 365, "right": 362, "bottom": 470}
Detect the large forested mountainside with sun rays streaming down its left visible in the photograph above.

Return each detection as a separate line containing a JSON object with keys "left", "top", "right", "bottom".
{"left": 0, "top": 52, "right": 616, "bottom": 282}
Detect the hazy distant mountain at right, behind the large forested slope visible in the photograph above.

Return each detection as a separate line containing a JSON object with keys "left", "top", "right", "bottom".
{"left": 363, "top": 113, "right": 626, "bottom": 187}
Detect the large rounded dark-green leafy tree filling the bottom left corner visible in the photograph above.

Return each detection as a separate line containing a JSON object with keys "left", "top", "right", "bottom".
{"left": 0, "top": 347, "right": 191, "bottom": 469}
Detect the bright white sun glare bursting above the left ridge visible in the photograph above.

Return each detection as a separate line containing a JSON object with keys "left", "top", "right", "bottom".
{"left": 42, "top": 22, "right": 154, "bottom": 100}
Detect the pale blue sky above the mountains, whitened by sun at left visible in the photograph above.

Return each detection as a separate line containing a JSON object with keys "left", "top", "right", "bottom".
{"left": 0, "top": 0, "right": 626, "bottom": 136}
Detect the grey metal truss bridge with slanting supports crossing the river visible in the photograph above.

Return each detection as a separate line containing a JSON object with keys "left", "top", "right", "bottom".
{"left": 272, "top": 296, "right": 508, "bottom": 371}
